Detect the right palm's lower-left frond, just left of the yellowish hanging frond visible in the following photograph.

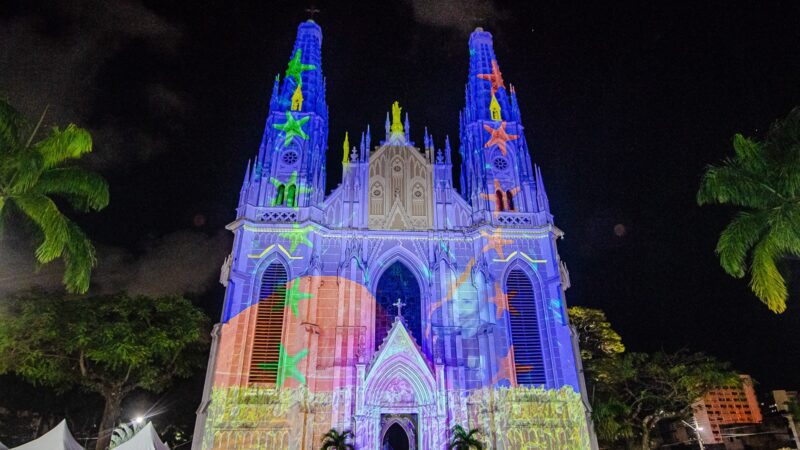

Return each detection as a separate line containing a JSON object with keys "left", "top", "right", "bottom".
{"left": 717, "top": 211, "right": 767, "bottom": 278}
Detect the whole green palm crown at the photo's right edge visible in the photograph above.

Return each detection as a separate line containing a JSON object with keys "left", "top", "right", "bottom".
{"left": 697, "top": 108, "right": 800, "bottom": 313}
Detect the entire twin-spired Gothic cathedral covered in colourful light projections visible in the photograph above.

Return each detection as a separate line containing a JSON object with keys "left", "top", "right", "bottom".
{"left": 193, "top": 20, "right": 595, "bottom": 450}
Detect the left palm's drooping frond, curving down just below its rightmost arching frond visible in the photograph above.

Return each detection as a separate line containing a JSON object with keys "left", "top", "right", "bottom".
{"left": 10, "top": 194, "right": 70, "bottom": 264}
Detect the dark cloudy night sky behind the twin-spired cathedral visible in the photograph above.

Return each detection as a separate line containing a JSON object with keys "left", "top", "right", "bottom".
{"left": 0, "top": 0, "right": 800, "bottom": 388}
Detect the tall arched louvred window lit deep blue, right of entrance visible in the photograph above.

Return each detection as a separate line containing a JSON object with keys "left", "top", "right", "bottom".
{"left": 506, "top": 269, "right": 546, "bottom": 385}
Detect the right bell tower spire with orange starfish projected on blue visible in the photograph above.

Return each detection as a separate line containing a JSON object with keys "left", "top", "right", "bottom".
{"left": 460, "top": 28, "right": 551, "bottom": 222}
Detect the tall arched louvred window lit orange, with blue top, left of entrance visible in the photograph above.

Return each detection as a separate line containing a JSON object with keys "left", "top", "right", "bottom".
{"left": 248, "top": 262, "right": 287, "bottom": 383}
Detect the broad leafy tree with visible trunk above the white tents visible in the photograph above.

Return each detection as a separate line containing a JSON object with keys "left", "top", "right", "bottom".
{"left": 0, "top": 293, "right": 209, "bottom": 450}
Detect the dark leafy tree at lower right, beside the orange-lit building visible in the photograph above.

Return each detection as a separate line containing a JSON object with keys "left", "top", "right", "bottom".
{"left": 592, "top": 351, "right": 739, "bottom": 450}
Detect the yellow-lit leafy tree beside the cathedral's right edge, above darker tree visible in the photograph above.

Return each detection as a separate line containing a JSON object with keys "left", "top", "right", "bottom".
{"left": 569, "top": 306, "right": 625, "bottom": 364}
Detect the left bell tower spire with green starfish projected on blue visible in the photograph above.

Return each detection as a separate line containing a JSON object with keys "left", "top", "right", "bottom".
{"left": 237, "top": 20, "right": 328, "bottom": 221}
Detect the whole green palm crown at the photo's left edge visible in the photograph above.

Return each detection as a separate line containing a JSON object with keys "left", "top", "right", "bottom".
{"left": 0, "top": 99, "right": 108, "bottom": 293}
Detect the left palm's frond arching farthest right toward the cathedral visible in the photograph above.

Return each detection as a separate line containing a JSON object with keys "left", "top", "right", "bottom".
{"left": 34, "top": 167, "right": 109, "bottom": 211}
